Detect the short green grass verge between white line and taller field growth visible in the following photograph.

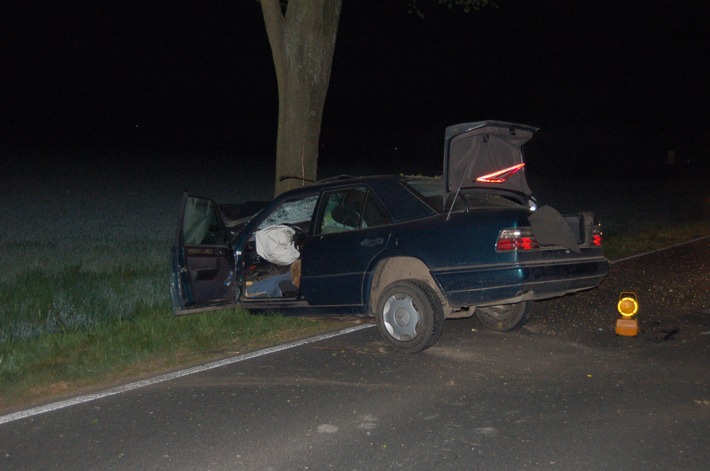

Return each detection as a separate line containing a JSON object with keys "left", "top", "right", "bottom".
{"left": 0, "top": 303, "right": 339, "bottom": 409}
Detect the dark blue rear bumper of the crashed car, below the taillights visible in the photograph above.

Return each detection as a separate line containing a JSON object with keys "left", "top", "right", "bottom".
{"left": 432, "top": 256, "right": 609, "bottom": 307}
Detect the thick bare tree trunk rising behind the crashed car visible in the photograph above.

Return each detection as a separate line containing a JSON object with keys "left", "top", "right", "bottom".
{"left": 261, "top": 0, "right": 342, "bottom": 195}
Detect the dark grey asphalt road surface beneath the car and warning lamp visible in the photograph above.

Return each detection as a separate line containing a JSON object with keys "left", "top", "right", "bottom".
{"left": 0, "top": 239, "right": 710, "bottom": 471}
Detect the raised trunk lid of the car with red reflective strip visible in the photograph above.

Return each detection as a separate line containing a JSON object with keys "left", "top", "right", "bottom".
{"left": 444, "top": 121, "right": 537, "bottom": 196}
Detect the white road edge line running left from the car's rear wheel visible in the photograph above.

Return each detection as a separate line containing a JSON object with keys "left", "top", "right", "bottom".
{"left": 0, "top": 324, "right": 375, "bottom": 425}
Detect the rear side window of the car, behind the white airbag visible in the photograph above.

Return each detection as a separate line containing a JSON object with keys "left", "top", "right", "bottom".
{"left": 316, "top": 188, "right": 389, "bottom": 234}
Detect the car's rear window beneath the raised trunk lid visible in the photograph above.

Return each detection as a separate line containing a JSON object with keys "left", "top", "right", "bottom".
{"left": 404, "top": 180, "right": 525, "bottom": 213}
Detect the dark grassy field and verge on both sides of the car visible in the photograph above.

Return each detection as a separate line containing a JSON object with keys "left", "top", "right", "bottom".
{"left": 0, "top": 148, "right": 710, "bottom": 410}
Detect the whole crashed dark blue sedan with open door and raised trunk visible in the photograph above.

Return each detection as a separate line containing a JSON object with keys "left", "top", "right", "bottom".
{"left": 171, "top": 121, "right": 608, "bottom": 352}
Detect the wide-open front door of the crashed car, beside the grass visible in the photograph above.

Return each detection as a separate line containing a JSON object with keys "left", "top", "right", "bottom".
{"left": 170, "top": 193, "right": 238, "bottom": 315}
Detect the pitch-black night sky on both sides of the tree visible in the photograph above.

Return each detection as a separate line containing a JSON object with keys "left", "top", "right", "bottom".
{"left": 0, "top": 0, "right": 710, "bottom": 177}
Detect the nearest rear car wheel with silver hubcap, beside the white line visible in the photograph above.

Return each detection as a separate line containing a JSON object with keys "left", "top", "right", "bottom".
{"left": 375, "top": 280, "right": 444, "bottom": 353}
